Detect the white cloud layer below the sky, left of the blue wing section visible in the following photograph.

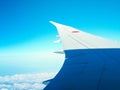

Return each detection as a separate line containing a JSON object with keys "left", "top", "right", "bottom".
{"left": 0, "top": 72, "right": 56, "bottom": 90}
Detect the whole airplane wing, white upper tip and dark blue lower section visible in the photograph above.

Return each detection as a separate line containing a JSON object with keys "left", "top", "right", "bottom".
{"left": 44, "top": 21, "right": 120, "bottom": 90}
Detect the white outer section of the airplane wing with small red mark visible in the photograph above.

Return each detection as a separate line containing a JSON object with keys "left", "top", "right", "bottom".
{"left": 50, "top": 21, "right": 120, "bottom": 50}
